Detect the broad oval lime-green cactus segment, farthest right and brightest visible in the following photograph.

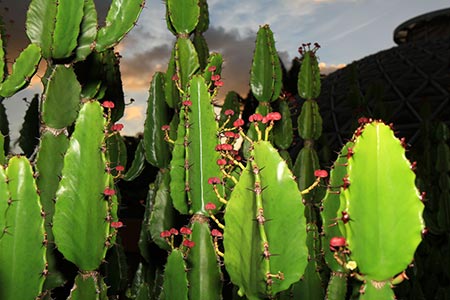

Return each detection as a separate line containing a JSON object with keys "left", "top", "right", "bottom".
{"left": 338, "top": 122, "right": 424, "bottom": 281}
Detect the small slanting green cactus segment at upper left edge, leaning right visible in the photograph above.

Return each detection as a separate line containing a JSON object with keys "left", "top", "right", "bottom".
{"left": 0, "top": 44, "right": 41, "bottom": 98}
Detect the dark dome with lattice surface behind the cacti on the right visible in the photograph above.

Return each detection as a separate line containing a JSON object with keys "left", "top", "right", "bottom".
{"left": 318, "top": 9, "right": 450, "bottom": 149}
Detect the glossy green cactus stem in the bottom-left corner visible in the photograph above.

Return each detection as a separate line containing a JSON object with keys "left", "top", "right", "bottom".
{"left": 0, "top": 156, "right": 48, "bottom": 300}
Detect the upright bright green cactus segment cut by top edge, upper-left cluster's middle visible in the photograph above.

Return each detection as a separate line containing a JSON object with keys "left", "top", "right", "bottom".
{"left": 51, "top": 0, "right": 85, "bottom": 59}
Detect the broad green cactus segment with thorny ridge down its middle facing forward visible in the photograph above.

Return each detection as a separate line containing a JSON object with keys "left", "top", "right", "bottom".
{"left": 224, "top": 141, "right": 308, "bottom": 299}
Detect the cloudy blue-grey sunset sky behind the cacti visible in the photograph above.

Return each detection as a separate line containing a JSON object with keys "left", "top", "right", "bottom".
{"left": 0, "top": 0, "right": 450, "bottom": 148}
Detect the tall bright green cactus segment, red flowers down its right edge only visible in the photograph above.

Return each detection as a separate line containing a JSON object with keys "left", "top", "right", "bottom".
{"left": 53, "top": 102, "right": 114, "bottom": 271}
